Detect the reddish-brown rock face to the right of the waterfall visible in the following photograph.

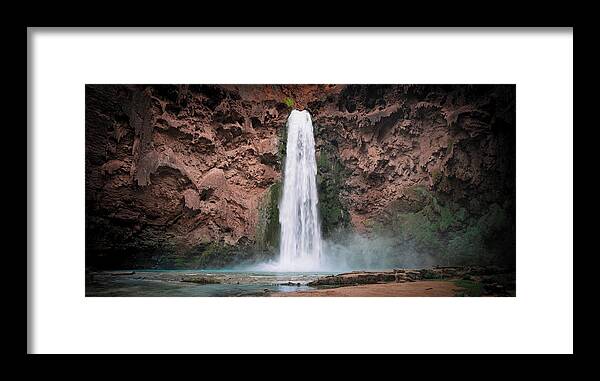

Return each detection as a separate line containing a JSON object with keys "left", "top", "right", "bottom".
{"left": 307, "top": 85, "right": 516, "bottom": 265}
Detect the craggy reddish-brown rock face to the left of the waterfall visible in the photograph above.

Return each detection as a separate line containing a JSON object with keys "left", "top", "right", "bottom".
{"left": 86, "top": 85, "right": 288, "bottom": 266}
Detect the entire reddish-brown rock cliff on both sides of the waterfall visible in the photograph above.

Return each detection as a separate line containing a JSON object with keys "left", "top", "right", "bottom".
{"left": 85, "top": 85, "right": 515, "bottom": 267}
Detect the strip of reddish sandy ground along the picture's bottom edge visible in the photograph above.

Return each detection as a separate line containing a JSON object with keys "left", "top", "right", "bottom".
{"left": 271, "top": 280, "right": 461, "bottom": 297}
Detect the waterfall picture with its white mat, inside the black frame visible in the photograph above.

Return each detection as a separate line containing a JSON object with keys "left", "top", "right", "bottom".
{"left": 28, "top": 28, "right": 573, "bottom": 353}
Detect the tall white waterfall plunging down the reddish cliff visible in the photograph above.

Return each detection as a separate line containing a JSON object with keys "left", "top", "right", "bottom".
{"left": 278, "top": 110, "right": 321, "bottom": 271}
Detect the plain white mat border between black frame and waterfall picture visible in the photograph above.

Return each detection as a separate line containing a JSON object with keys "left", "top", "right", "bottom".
{"left": 28, "top": 29, "right": 573, "bottom": 353}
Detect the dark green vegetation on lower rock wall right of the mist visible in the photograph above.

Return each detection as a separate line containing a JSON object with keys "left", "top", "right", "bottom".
{"left": 369, "top": 186, "right": 515, "bottom": 265}
